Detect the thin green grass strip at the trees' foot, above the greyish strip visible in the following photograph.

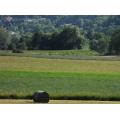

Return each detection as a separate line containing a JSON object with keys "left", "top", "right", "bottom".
{"left": 0, "top": 49, "right": 98, "bottom": 57}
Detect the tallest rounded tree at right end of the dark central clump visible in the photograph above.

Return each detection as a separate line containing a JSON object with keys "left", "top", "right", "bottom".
{"left": 58, "top": 25, "right": 84, "bottom": 49}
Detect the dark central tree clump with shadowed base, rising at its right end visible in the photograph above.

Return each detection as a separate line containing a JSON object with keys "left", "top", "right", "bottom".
{"left": 32, "top": 25, "right": 84, "bottom": 50}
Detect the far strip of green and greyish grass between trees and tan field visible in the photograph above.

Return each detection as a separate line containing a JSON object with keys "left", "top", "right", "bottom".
{"left": 0, "top": 49, "right": 120, "bottom": 61}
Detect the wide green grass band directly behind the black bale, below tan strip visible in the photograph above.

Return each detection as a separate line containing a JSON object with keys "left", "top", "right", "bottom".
{"left": 0, "top": 71, "right": 120, "bottom": 100}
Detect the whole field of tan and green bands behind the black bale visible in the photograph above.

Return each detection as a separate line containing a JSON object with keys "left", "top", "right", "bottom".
{"left": 0, "top": 56, "right": 120, "bottom": 100}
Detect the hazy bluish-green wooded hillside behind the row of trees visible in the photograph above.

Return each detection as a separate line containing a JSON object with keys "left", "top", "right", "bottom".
{"left": 0, "top": 15, "right": 120, "bottom": 35}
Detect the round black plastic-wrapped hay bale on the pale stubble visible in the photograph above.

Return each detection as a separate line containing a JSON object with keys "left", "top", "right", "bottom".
{"left": 33, "top": 91, "right": 49, "bottom": 103}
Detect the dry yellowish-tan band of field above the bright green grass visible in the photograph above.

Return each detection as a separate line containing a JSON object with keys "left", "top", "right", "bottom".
{"left": 0, "top": 56, "right": 120, "bottom": 73}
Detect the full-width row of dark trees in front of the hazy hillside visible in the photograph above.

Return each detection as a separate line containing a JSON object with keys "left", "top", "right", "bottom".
{"left": 0, "top": 25, "right": 120, "bottom": 55}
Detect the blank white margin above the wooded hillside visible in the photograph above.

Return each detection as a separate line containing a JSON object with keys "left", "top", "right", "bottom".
{"left": 0, "top": 0, "right": 120, "bottom": 15}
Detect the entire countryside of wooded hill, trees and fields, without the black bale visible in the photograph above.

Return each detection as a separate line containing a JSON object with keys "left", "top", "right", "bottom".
{"left": 0, "top": 15, "right": 120, "bottom": 104}
